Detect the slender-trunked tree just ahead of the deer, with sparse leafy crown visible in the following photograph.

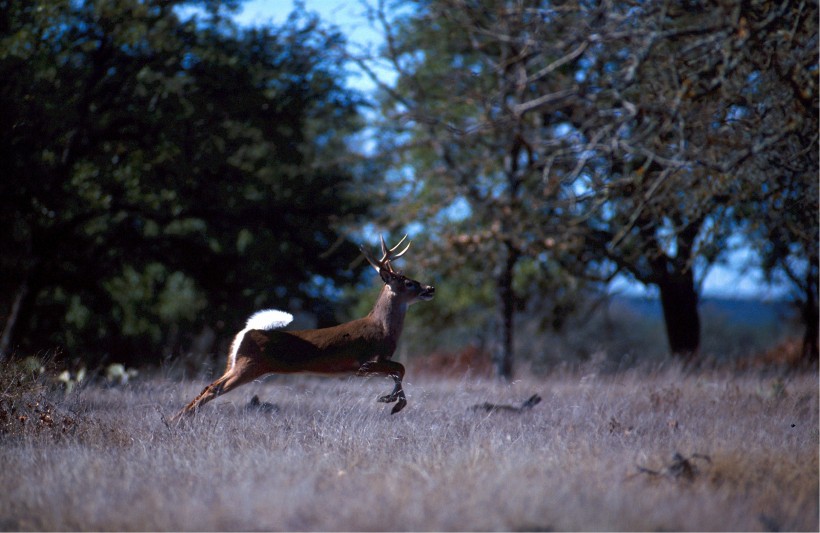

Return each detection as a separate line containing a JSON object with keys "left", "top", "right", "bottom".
{"left": 362, "top": 1, "right": 583, "bottom": 378}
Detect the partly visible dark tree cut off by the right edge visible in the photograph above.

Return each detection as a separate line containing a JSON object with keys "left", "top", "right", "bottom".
{"left": 716, "top": 2, "right": 820, "bottom": 363}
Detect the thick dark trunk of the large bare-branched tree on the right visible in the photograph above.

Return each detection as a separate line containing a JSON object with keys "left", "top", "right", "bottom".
{"left": 658, "top": 269, "right": 700, "bottom": 360}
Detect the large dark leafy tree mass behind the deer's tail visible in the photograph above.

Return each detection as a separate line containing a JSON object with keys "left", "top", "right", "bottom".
{"left": 0, "top": 0, "right": 368, "bottom": 363}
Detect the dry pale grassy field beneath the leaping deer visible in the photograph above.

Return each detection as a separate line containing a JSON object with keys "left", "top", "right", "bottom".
{"left": 0, "top": 364, "right": 819, "bottom": 531}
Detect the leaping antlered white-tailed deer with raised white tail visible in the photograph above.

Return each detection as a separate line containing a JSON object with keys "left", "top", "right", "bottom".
{"left": 174, "top": 236, "right": 435, "bottom": 420}
